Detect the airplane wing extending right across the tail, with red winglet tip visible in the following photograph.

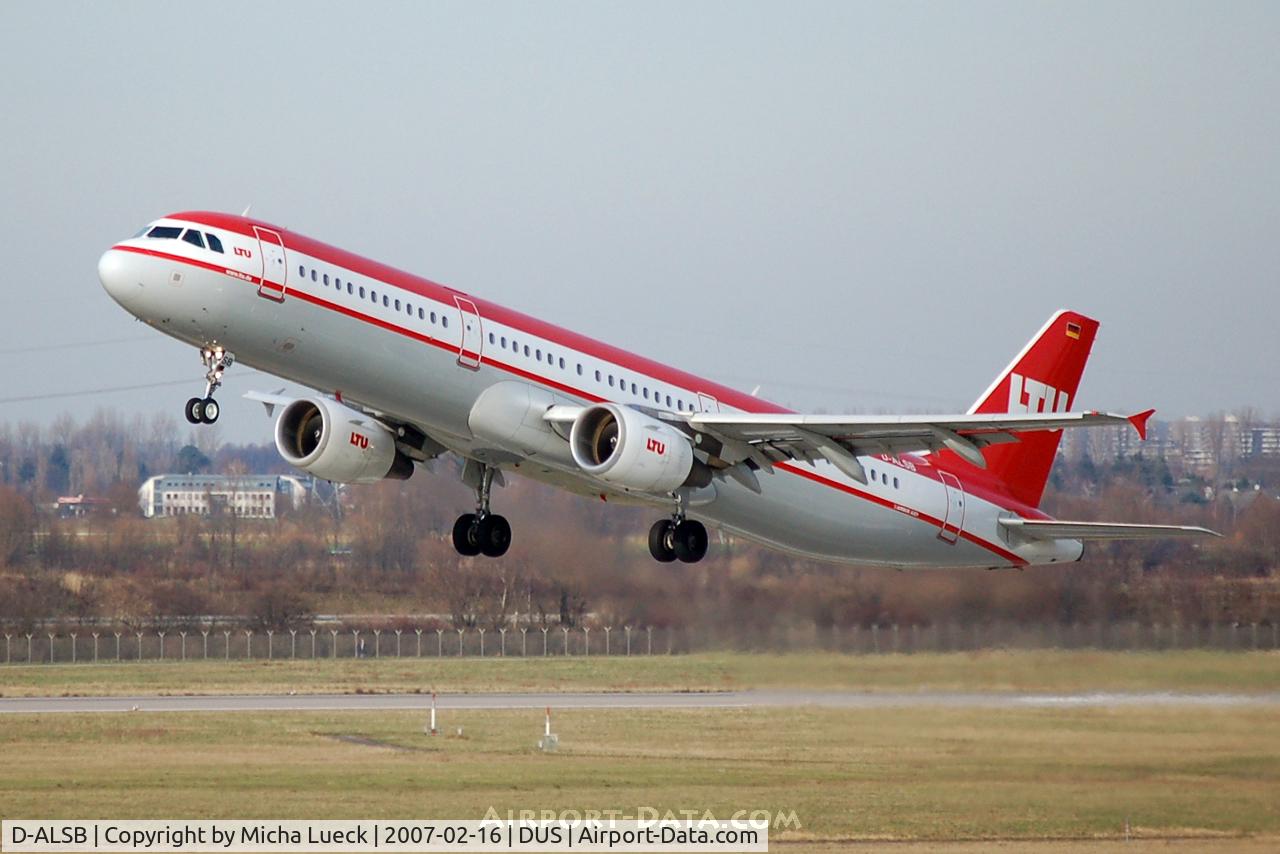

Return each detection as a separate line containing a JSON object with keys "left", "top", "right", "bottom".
{"left": 687, "top": 410, "right": 1155, "bottom": 483}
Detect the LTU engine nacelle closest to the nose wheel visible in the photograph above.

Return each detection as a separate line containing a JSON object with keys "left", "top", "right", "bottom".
{"left": 275, "top": 397, "right": 413, "bottom": 483}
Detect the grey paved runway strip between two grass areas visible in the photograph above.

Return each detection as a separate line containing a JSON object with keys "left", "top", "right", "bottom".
{"left": 0, "top": 690, "right": 1280, "bottom": 714}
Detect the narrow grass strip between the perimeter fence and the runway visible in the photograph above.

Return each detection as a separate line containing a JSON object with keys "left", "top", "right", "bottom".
{"left": 0, "top": 650, "right": 1280, "bottom": 697}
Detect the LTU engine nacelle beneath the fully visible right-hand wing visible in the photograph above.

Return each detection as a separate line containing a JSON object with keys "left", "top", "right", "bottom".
{"left": 570, "top": 403, "right": 705, "bottom": 493}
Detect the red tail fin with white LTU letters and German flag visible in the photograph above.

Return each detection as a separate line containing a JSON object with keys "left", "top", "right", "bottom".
{"left": 969, "top": 311, "right": 1098, "bottom": 507}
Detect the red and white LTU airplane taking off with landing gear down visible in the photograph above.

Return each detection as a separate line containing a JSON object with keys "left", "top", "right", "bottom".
{"left": 99, "top": 211, "right": 1216, "bottom": 568}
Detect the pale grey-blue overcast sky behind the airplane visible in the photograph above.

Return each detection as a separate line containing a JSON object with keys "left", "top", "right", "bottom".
{"left": 0, "top": 1, "right": 1280, "bottom": 440}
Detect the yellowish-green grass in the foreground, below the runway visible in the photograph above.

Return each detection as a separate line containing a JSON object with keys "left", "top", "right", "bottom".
{"left": 0, "top": 708, "right": 1280, "bottom": 850}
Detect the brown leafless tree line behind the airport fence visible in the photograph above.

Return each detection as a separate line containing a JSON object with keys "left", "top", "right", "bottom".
{"left": 0, "top": 411, "right": 1280, "bottom": 645}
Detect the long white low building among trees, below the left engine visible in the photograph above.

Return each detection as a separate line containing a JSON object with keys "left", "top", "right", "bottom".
{"left": 138, "top": 475, "right": 312, "bottom": 519}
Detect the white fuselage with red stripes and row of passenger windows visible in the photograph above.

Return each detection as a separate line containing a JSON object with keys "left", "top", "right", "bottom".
{"left": 100, "top": 219, "right": 1082, "bottom": 567}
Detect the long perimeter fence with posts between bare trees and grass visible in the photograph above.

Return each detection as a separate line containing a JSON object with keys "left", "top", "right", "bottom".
{"left": 0, "top": 622, "right": 1280, "bottom": 665}
